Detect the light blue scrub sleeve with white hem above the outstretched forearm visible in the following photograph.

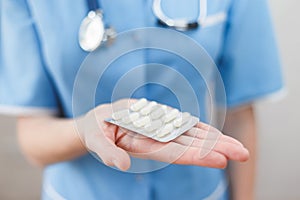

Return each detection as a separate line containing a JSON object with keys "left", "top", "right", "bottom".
{"left": 0, "top": 0, "right": 58, "bottom": 115}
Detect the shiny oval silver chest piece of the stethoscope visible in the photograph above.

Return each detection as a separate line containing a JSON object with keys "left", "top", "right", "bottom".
{"left": 79, "top": 11, "right": 105, "bottom": 51}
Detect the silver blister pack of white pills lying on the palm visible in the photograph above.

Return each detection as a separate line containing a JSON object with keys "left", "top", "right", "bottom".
{"left": 105, "top": 98, "right": 199, "bottom": 142}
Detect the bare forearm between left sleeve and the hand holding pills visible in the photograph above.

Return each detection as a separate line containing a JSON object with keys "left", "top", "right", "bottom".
{"left": 17, "top": 117, "right": 86, "bottom": 166}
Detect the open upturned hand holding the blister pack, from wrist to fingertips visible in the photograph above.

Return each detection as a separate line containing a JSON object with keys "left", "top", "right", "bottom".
{"left": 77, "top": 99, "right": 249, "bottom": 170}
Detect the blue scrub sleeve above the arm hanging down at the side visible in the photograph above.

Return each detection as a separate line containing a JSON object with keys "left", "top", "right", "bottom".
{"left": 218, "top": 0, "right": 283, "bottom": 108}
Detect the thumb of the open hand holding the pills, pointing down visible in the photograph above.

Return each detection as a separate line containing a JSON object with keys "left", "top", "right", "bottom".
{"left": 87, "top": 134, "right": 130, "bottom": 171}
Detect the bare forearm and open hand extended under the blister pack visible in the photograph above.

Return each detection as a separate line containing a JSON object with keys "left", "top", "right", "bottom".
{"left": 18, "top": 99, "right": 249, "bottom": 195}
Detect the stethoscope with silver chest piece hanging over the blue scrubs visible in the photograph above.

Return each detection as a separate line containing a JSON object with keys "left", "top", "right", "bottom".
{"left": 79, "top": 0, "right": 207, "bottom": 52}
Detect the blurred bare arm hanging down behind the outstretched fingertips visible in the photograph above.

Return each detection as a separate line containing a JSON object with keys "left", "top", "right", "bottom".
{"left": 223, "top": 106, "right": 256, "bottom": 200}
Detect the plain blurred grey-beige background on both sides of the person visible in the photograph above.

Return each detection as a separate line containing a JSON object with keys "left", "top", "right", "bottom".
{"left": 0, "top": 0, "right": 300, "bottom": 200}
